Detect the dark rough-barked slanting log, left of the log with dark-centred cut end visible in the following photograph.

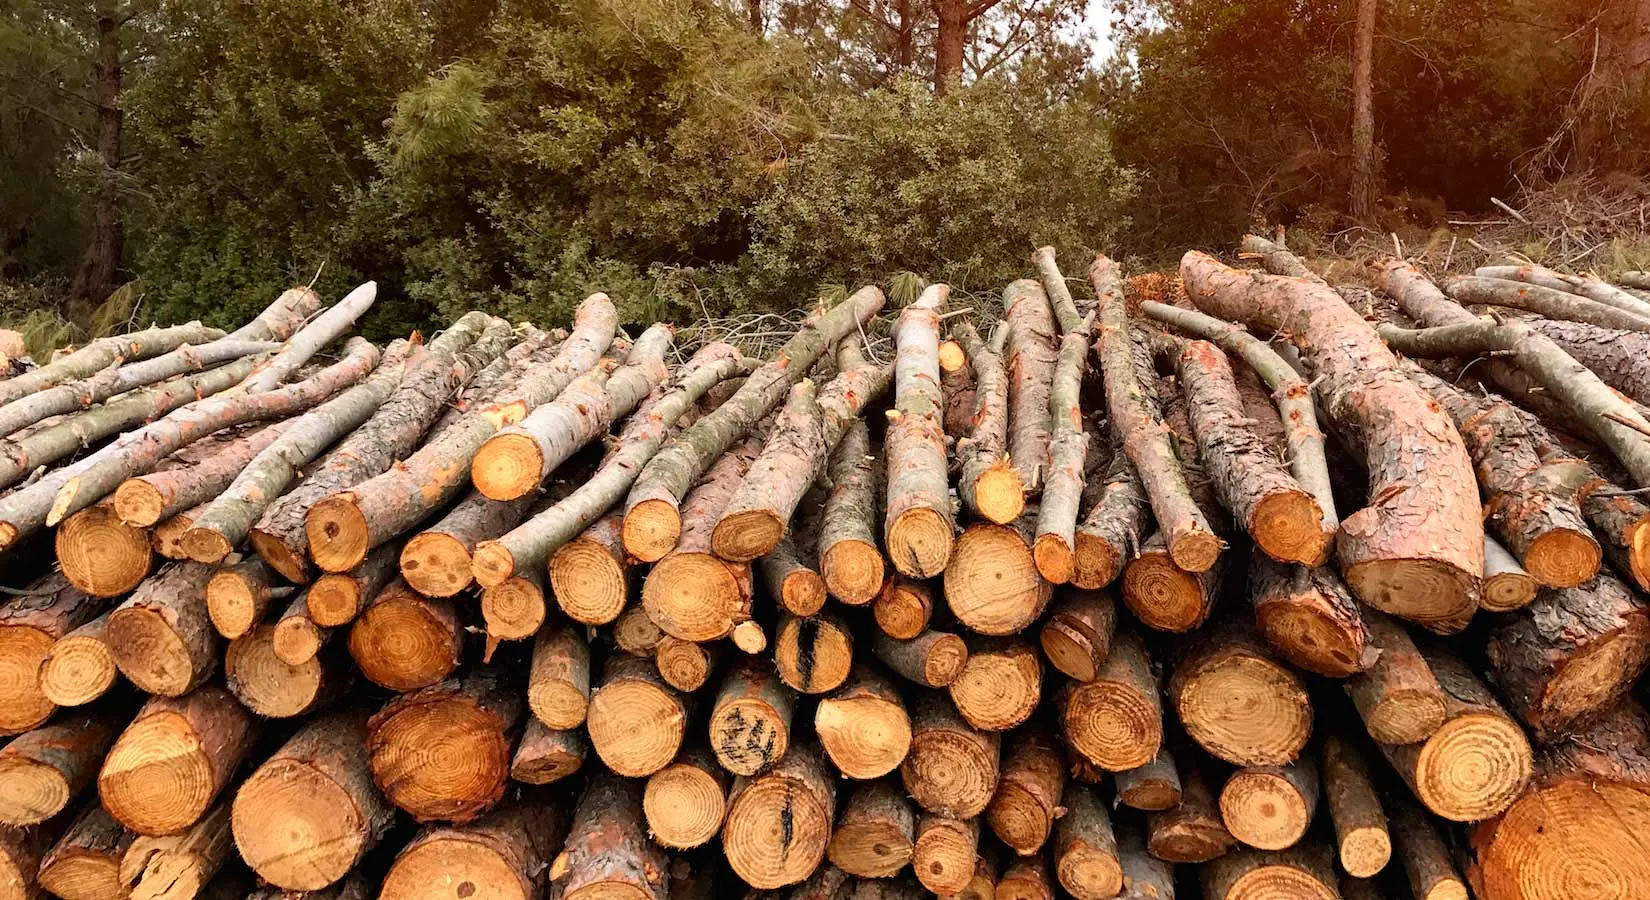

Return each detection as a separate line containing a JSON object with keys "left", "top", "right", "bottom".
{"left": 248, "top": 312, "right": 511, "bottom": 583}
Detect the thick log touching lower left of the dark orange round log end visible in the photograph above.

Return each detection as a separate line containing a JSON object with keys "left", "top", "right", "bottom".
{"left": 231, "top": 708, "right": 394, "bottom": 890}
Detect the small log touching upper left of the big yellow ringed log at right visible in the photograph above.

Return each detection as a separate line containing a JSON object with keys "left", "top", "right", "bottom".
{"left": 1345, "top": 613, "right": 1449, "bottom": 743}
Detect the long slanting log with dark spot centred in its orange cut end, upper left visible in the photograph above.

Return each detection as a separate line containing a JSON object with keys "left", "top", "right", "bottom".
{"left": 304, "top": 294, "right": 619, "bottom": 571}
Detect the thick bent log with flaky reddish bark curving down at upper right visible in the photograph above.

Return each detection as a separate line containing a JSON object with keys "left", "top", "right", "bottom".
{"left": 1180, "top": 253, "right": 1483, "bottom": 631}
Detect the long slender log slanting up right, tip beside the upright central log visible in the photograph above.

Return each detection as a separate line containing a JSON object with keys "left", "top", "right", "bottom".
{"left": 624, "top": 286, "right": 883, "bottom": 563}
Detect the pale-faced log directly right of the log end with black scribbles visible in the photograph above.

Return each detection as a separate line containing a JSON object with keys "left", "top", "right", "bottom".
{"left": 813, "top": 662, "right": 911, "bottom": 779}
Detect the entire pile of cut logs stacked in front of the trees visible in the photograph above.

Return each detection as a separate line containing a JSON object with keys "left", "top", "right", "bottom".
{"left": 0, "top": 236, "right": 1650, "bottom": 900}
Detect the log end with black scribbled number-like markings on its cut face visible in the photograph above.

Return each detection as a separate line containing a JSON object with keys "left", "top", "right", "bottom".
{"left": 710, "top": 659, "right": 797, "bottom": 774}
